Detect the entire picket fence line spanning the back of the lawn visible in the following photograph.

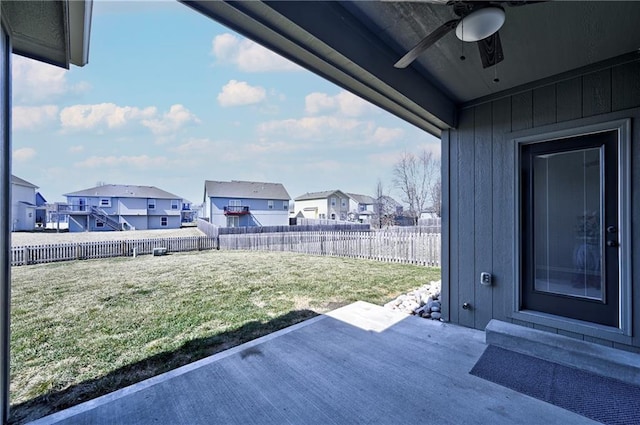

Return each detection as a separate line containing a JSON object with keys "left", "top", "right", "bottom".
{"left": 11, "top": 231, "right": 440, "bottom": 267}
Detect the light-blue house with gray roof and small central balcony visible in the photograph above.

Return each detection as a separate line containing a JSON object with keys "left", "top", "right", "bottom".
{"left": 204, "top": 180, "right": 291, "bottom": 227}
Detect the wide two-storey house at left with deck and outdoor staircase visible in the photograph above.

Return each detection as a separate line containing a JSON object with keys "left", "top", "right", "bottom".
{"left": 64, "top": 184, "right": 182, "bottom": 232}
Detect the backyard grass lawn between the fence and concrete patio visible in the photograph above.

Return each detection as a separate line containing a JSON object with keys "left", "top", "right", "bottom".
{"left": 11, "top": 251, "right": 440, "bottom": 423}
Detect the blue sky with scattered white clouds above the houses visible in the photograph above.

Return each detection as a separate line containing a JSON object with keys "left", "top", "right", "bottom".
{"left": 12, "top": 0, "right": 440, "bottom": 203}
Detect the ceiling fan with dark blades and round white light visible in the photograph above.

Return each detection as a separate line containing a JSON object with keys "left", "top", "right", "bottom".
{"left": 394, "top": 0, "right": 539, "bottom": 68}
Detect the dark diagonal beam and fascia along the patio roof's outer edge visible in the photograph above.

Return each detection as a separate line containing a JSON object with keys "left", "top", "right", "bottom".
{"left": 180, "top": 0, "right": 456, "bottom": 137}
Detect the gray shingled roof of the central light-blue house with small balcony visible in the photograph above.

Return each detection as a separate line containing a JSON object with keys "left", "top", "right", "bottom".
{"left": 204, "top": 180, "right": 291, "bottom": 201}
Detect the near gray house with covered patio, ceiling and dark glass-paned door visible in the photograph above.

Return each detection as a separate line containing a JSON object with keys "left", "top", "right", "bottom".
{"left": 187, "top": 1, "right": 640, "bottom": 352}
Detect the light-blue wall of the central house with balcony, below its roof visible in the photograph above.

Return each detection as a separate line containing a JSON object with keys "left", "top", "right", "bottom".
{"left": 207, "top": 197, "right": 289, "bottom": 227}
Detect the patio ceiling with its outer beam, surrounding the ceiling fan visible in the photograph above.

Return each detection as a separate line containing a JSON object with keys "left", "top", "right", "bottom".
{"left": 184, "top": 0, "right": 640, "bottom": 136}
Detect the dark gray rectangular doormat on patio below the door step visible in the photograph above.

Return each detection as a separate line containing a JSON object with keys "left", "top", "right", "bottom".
{"left": 469, "top": 345, "right": 640, "bottom": 425}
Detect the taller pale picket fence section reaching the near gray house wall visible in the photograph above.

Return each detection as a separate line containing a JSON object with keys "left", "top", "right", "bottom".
{"left": 219, "top": 232, "right": 440, "bottom": 267}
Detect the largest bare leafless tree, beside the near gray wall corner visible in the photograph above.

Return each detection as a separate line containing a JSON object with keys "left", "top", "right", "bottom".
{"left": 393, "top": 149, "right": 440, "bottom": 224}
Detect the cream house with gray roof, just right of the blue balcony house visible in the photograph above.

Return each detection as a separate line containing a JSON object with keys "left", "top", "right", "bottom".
{"left": 295, "top": 190, "right": 351, "bottom": 221}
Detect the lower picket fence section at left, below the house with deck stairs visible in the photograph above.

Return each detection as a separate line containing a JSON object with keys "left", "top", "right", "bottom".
{"left": 11, "top": 236, "right": 218, "bottom": 266}
